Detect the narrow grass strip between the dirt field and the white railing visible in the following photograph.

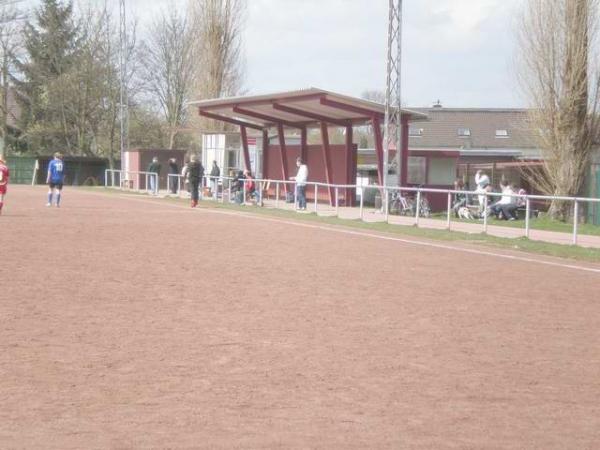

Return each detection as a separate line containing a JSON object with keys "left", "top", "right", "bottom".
{"left": 86, "top": 187, "right": 600, "bottom": 262}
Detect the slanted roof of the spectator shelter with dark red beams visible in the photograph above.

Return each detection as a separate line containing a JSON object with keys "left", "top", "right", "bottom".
{"left": 189, "top": 88, "right": 427, "bottom": 129}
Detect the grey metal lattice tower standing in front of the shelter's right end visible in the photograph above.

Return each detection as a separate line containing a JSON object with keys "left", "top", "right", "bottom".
{"left": 383, "top": 0, "right": 402, "bottom": 186}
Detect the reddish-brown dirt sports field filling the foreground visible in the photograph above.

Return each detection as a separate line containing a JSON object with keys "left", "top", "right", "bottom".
{"left": 0, "top": 186, "right": 600, "bottom": 449}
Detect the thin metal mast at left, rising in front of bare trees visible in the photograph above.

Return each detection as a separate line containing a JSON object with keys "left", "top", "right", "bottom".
{"left": 119, "top": 0, "right": 129, "bottom": 178}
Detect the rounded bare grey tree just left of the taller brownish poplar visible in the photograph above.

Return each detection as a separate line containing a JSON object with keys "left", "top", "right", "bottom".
{"left": 142, "top": 7, "right": 198, "bottom": 149}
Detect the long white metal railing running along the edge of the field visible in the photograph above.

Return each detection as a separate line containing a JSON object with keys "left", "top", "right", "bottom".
{"left": 105, "top": 169, "right": 600, "bottom": 245}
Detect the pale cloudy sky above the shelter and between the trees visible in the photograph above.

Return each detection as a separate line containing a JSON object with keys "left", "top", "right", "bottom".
{"left": 27, "top": 0, "right": 526, "bottom": 107}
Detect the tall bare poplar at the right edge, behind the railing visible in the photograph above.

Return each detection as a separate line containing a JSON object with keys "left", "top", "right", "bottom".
{"left": 519, "top": 0, "right": 600, "bottom": 220}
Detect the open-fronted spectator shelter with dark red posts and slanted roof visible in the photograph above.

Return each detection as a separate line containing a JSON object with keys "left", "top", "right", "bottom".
{"left": 190, "top": 88, "right": 427, "bottom": 204}
